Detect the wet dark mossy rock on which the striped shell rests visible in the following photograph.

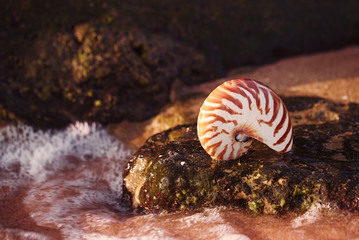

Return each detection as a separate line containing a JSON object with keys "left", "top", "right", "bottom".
{"left": 124, "top": 97, "right": 359, "bottom": 214}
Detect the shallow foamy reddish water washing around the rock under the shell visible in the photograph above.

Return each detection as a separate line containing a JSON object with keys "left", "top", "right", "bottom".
{"left": 0, "top": 123, "right": 359, "bottom": 240}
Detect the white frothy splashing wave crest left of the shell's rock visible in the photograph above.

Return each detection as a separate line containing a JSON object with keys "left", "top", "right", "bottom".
{"left": 0, "top": 122, "right": 130, "bottom": 190}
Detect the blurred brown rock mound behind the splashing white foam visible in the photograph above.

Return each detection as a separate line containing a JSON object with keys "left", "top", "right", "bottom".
{"left": 0, "top": 24, "right": 211, "bottom": 127}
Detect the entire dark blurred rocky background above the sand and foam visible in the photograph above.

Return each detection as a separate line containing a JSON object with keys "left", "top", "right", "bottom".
{"left": 0, "top": 0, "right": 359, "bottom": 127}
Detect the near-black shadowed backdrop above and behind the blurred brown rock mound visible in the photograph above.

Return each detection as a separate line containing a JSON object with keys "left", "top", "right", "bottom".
{"left": 0, "top": 0, "right": 359, "bottom": 70}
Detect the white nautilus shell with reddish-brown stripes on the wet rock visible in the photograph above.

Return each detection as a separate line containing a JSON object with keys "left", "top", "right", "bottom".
{"left": 197, "top": 79, "right": 293, "bottom": 160}
